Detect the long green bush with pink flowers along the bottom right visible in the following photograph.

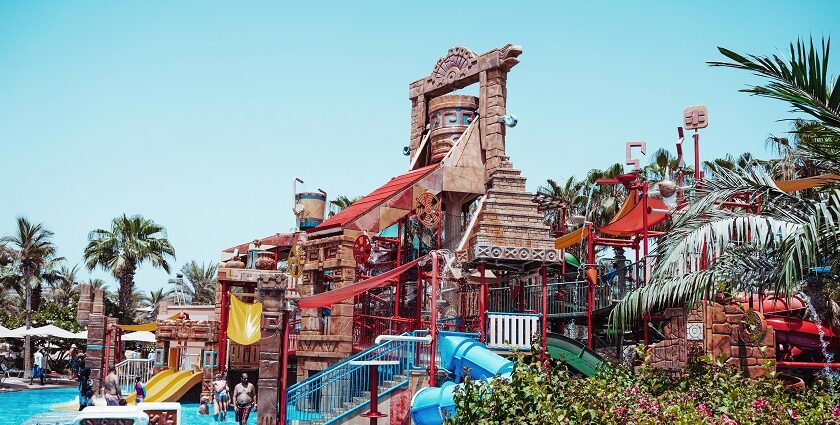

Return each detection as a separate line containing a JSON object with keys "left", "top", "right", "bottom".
{"left": 446, "top": 350, "right": 840, "bottom": 425}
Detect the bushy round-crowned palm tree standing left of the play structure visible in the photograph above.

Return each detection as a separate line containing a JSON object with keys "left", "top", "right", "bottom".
{"left": 84, "top": 215, "right": 175, "bottom": 320}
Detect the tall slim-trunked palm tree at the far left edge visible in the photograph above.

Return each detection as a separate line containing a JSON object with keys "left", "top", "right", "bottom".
{"left": 0, "top": 217, "right": 55, "bottom": 371}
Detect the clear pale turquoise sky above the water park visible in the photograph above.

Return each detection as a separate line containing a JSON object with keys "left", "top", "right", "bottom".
{"left": 0, "top": 0, "right": 840, "bottom": 291}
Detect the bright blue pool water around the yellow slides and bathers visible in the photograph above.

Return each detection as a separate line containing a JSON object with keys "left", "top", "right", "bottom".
{"left": 0, "top": 388, "right": 257, "bottom": 425}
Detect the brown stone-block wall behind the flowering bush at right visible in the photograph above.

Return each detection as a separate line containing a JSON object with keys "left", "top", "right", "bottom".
{"left": 648, "top": 302, "right": 776, "bottom": 377}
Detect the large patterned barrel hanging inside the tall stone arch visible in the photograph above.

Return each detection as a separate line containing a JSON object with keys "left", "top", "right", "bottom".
{"left": 429, "top": 94, "right": 478, "bottom": 162}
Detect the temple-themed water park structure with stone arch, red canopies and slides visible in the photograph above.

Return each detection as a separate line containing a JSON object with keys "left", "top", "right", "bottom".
{"left": 64, "top": 44, "right": 840, "bottom": 425}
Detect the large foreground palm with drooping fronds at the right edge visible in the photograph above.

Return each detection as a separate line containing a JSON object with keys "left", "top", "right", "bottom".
{"left": 613, "top": 40, "right": 840, "bottom": 323}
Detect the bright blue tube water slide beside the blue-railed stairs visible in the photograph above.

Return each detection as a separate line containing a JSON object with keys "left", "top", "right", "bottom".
{"left": 411, "top": 336, "right": 513, "bottom": 425}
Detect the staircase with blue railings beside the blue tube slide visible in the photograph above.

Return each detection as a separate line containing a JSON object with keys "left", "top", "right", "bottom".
{"left": 286, "top": 333, "right": 429, "bottom": 425}
